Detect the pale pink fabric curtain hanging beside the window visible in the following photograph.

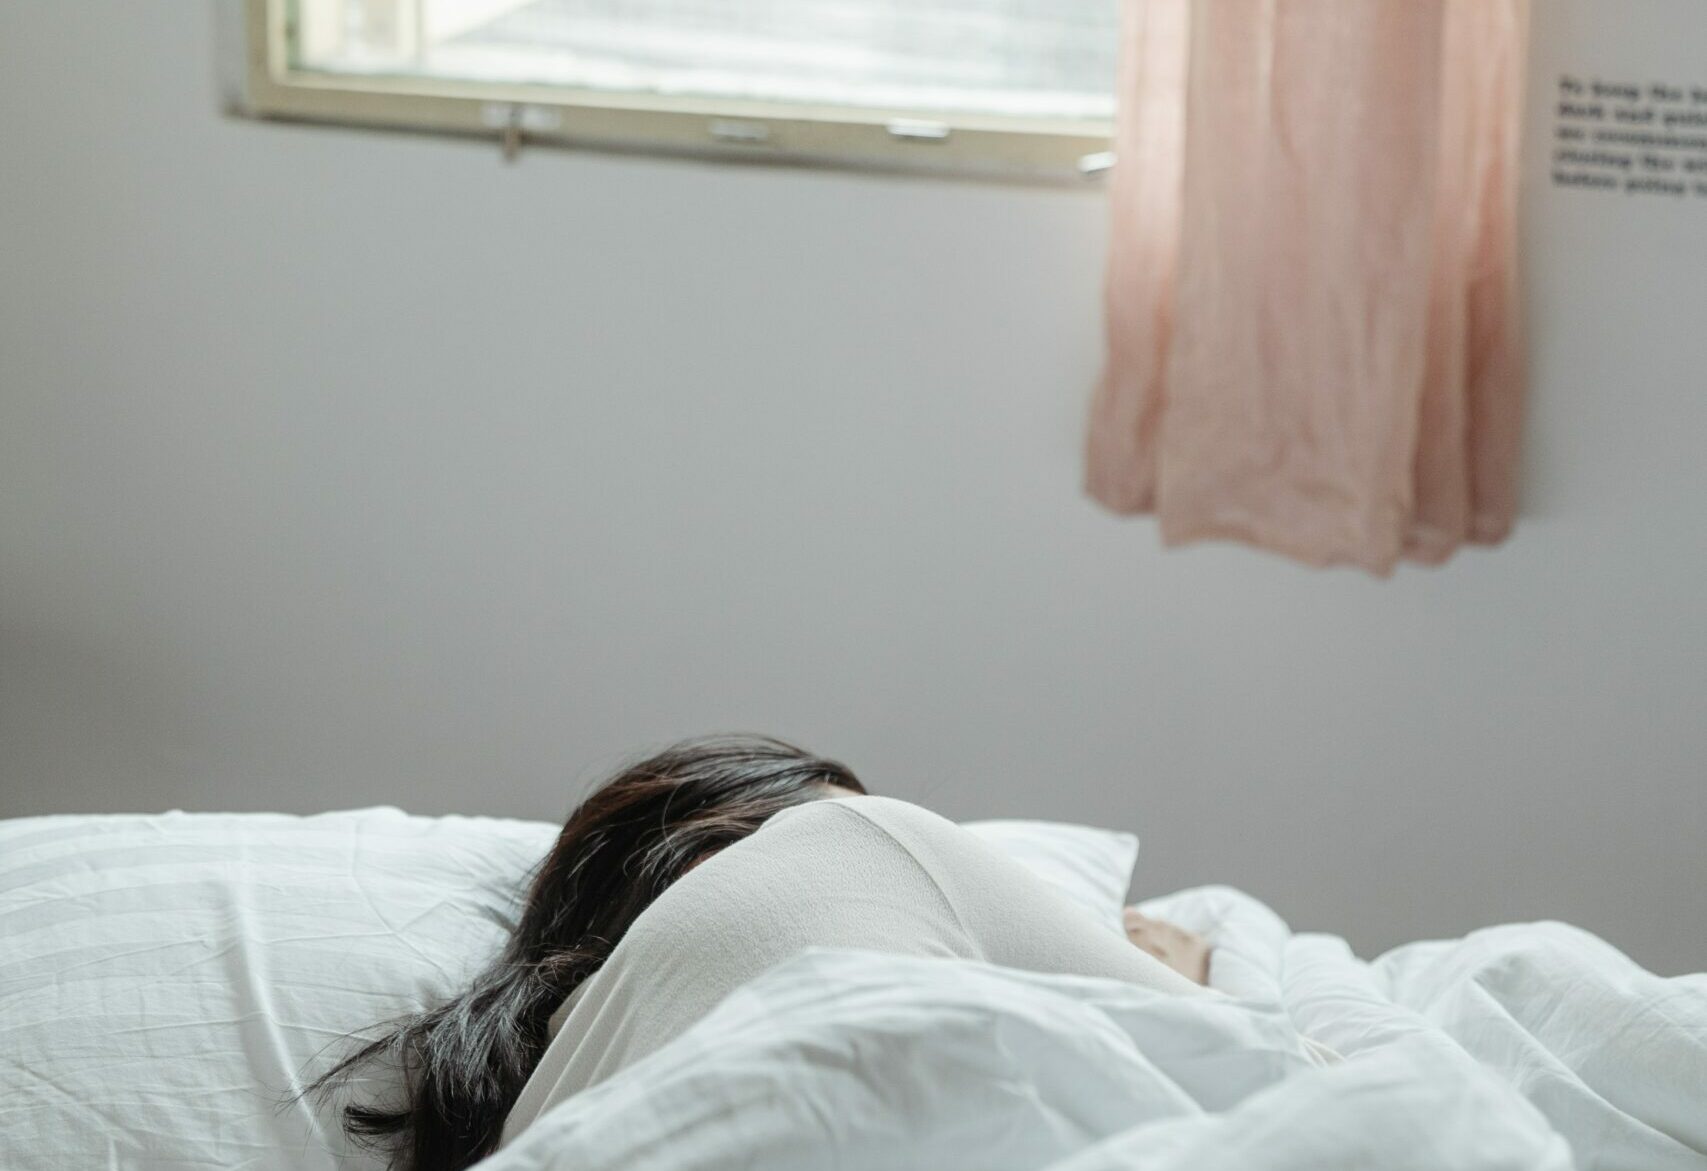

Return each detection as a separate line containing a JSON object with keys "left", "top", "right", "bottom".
{"left": 1086, "top": 0, "right": 1529, "bottom": 575}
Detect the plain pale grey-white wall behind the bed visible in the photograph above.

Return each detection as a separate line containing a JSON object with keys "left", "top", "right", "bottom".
{"left": 0, "top": 0, "right": 1707, "bottom": 970}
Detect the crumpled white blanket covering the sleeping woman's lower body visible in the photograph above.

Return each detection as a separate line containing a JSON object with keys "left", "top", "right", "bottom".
{"left": 481, "top": 888, "right": 1707, "bottom": 1171}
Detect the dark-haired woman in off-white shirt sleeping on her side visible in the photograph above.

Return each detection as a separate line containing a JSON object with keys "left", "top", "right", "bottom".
{"left": 309, "top": 737, "right": 1209, "bottom": 1171}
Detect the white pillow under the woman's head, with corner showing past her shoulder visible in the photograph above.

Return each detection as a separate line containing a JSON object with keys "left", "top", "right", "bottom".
{"left": 0, "top": 807, "right": 1137, "bottom": 1171}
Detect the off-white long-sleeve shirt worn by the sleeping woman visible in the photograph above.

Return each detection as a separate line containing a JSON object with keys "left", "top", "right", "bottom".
{"left": 498, "top": 795, "right": 1214, "bottom": 1147}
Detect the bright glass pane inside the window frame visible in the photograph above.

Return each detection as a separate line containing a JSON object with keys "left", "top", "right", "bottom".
{"left": 295, "top": 0, "right": 1118, "bottom": 119}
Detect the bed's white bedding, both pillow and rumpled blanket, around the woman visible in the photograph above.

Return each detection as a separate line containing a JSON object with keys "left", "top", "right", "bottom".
{"left": 0, "top": 807, "right": 1707, "bottom": 1171}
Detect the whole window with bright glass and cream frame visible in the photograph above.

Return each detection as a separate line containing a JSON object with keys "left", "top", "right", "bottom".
{"left": 248, "top": 0, "right": 1120, "bottom": 176}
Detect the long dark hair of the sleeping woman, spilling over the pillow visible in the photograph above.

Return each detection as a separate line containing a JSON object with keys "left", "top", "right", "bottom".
{"left": 304, "top": 736, "right": 865, "bottom": 1171}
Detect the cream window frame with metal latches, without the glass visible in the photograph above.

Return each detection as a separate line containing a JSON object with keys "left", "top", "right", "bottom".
{"left": 244, "top": 0, "right": 1113, "bottom": 183}
